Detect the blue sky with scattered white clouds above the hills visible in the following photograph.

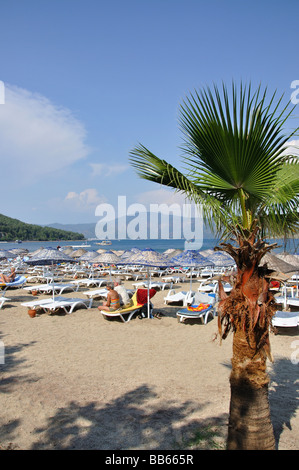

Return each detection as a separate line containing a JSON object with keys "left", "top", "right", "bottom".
{"left": 0, "top": 0, "right": 299, "bottom": 228}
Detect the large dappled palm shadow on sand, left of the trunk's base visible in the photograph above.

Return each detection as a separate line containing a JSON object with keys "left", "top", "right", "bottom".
{"left": 31, "top": 385, "right": 227, "bottom": 450}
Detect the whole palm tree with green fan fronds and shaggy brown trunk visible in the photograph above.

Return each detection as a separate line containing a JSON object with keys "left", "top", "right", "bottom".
{"left": 130, "top": 83, "right": 299, "bottom": 449}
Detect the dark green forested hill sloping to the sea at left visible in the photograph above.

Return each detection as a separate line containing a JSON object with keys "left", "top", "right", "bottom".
{"left": 0, "top": 214, "right": 85, "bottom": 241}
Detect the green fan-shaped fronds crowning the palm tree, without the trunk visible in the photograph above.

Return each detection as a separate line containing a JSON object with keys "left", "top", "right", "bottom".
{"left": 130, "top": 83, "right": 299, "bottom": 239}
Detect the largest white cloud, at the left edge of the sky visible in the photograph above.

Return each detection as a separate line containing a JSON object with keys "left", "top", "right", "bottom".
{"left": 0, "top": 85, "right": 89, "bottom": 181}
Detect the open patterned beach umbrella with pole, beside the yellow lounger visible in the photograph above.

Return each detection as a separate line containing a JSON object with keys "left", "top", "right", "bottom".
{"left": 123, "top": 248, "right": 171, "bottom": 318}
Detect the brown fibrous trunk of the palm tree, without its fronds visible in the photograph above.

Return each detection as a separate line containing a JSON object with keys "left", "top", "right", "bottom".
{"left": 218, "top": 224, "right": 276, "bottom": 450}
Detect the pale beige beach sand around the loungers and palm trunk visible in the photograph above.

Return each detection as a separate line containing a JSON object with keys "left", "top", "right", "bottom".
{"left": 0, "top": 282, "right": 299, "bottom": 450}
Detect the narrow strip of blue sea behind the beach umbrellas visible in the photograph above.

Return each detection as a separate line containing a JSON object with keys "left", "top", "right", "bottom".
{"left": 0, "top": 238, "right": 299, "bottom": 254}
